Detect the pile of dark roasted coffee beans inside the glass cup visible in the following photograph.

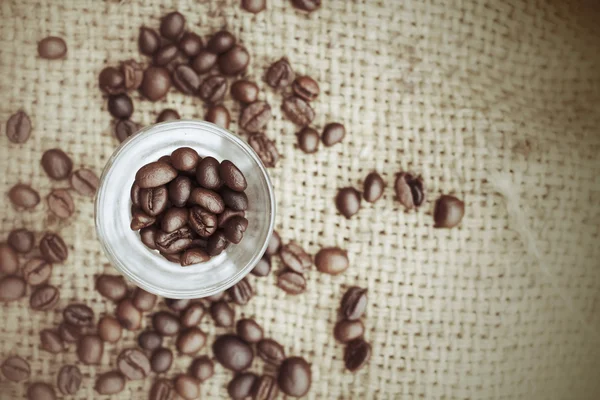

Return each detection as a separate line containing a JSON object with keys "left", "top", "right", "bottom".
{"left": 131, "top": 147, "right": 248, "bottom": 267}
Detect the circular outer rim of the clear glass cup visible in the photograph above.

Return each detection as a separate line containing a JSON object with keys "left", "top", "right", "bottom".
{"left": 94, "top": 119, "right": 276, "bottom": 299}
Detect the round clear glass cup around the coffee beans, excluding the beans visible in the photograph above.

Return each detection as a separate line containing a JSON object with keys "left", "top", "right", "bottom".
{"left": 95, "top": 120, "right": 275, "bottom": 299}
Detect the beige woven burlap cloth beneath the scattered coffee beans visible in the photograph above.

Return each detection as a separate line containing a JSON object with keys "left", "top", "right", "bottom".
{"left": 0, "top": 0, "right": 600, "bottom": 399}
